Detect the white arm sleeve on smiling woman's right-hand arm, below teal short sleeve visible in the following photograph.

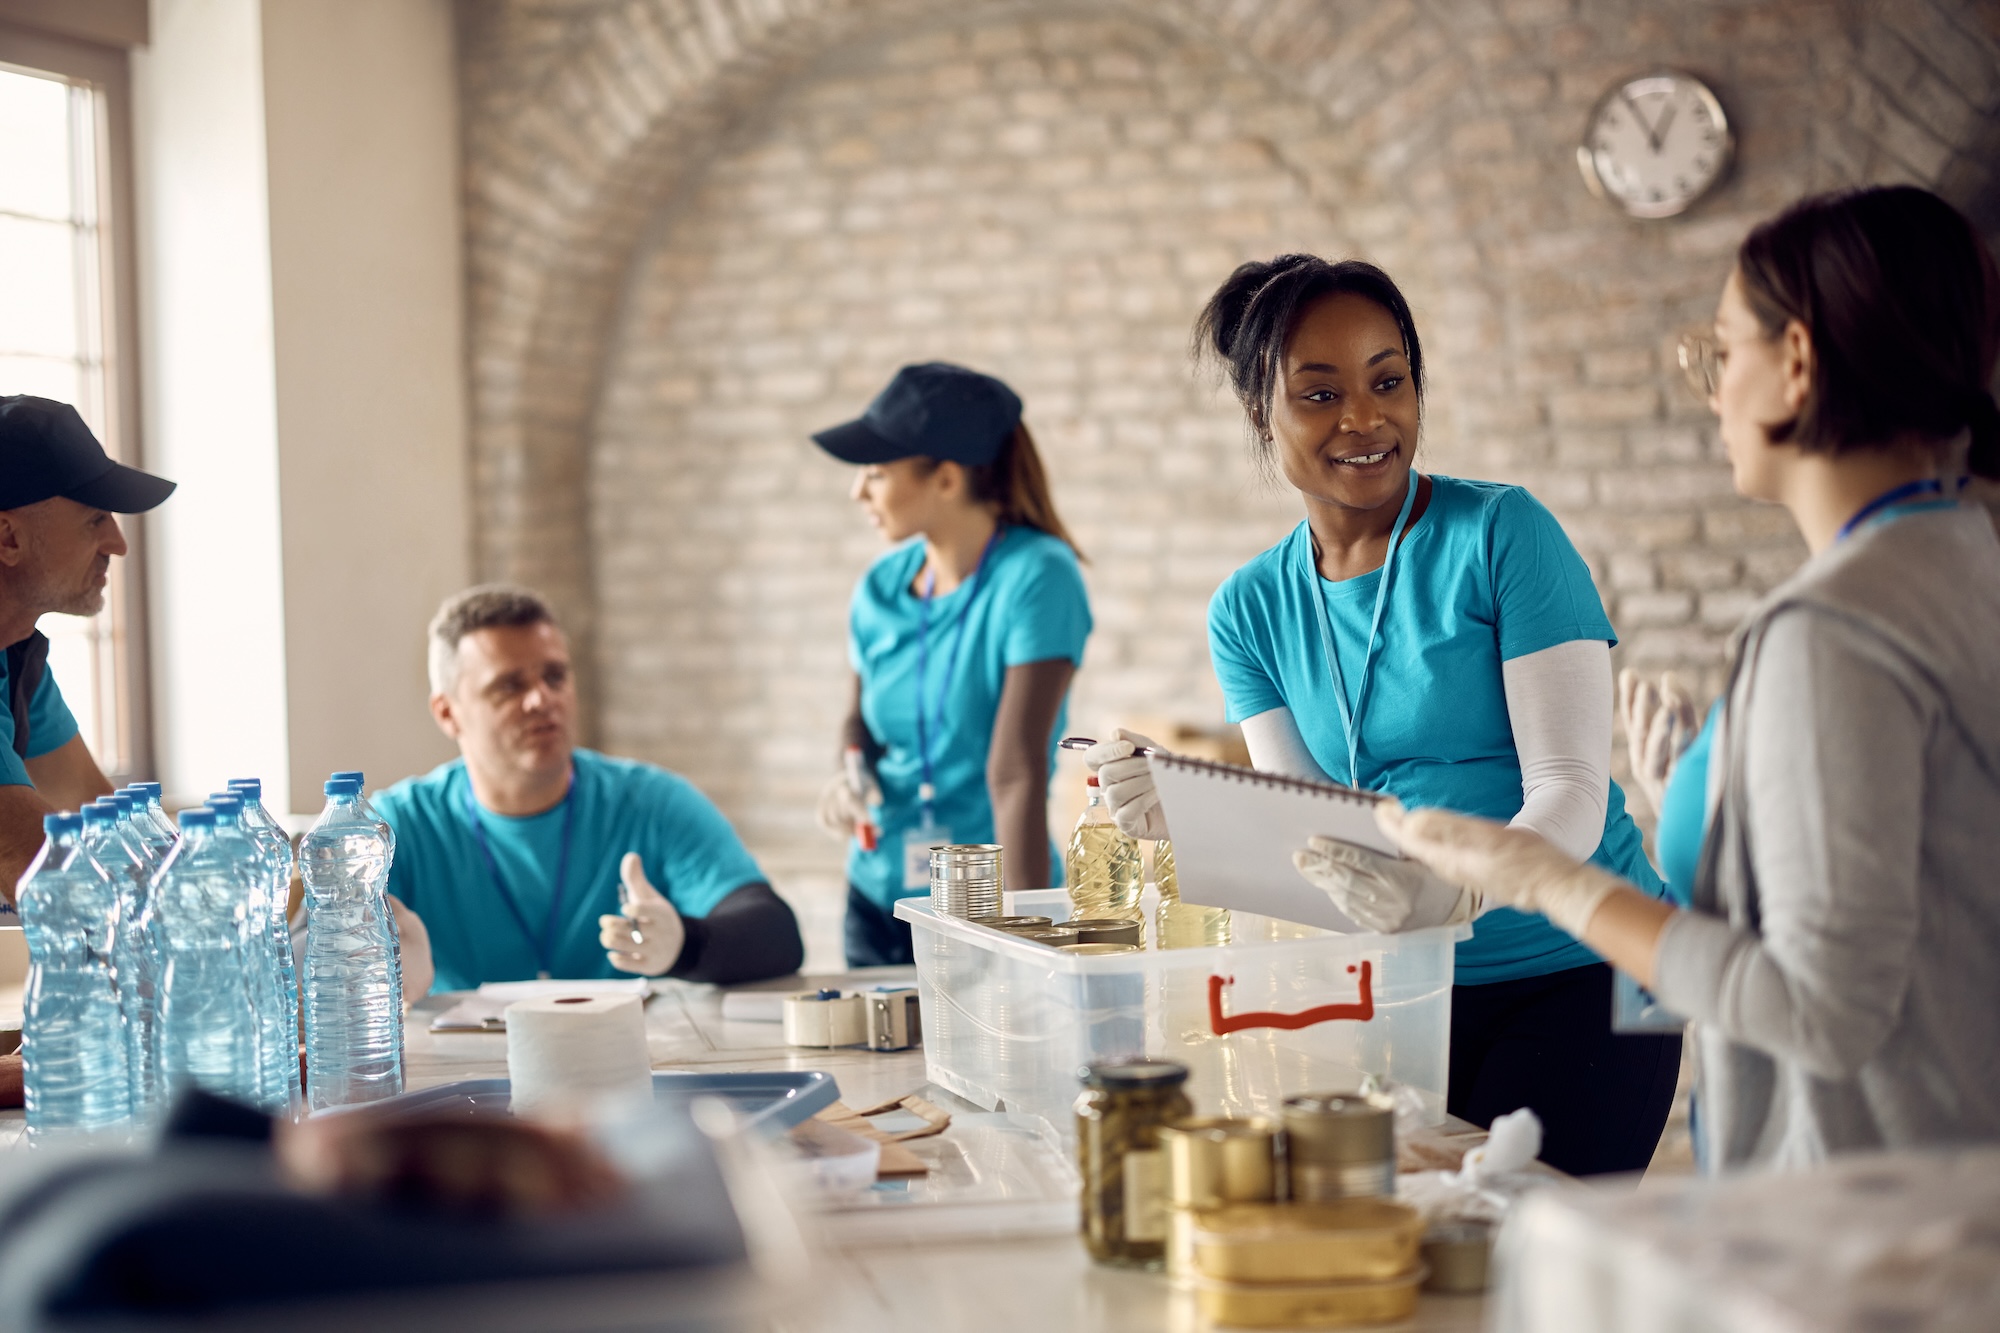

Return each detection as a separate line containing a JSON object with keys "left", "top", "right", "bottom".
{"left": 1504, "top": 638, "right": 1612, "bottom": 861}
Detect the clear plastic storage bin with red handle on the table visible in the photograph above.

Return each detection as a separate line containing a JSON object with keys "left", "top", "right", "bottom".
{"left": 896, "top": 889, "right": 1470, "bottom": 1141}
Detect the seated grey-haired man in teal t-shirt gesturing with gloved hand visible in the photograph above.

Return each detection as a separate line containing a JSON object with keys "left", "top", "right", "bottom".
{"left": 374, "top": 584, "right": 804, "bottom": 991}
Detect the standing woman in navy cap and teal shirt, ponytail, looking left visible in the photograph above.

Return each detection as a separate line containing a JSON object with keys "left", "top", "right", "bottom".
{"left": 812, "top": 362, "right": 1090, "bottom": 967}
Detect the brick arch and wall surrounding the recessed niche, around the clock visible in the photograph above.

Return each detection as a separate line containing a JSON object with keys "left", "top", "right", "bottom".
{"left": 460, "top": 0, "right": 2000, "bottom": 860}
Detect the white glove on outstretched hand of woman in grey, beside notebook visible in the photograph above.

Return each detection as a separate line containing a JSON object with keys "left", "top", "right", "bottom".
{"left": 1376, "top": 801, "right": 1624, "bottom": 937}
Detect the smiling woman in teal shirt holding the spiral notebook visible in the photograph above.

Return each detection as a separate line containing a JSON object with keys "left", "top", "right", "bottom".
{"left": 1084, "top": 254, "right": 1680, "bottom": 1175}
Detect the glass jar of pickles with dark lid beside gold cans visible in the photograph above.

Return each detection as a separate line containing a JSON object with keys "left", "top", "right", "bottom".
{"left": 1076, "top": 1059, "right": 1194, "bottom": 1269}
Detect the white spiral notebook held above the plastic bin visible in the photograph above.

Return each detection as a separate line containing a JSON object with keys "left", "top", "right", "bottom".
{"left": 1152, "top": 755, "right": 1400, "bottom": 933}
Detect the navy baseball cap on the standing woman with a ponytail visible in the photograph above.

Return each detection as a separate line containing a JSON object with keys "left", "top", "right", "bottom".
{"left": 812, "top": 360, "right": 1020, "bottom": 466}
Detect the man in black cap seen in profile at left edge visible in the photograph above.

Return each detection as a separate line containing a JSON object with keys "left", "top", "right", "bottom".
{"left": 0, "top": 394, "right": 174, "bottom": 892}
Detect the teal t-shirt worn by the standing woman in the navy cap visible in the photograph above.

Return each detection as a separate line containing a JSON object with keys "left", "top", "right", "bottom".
{"left": 848, "top": 526, "right": 1090, "bottom": 907}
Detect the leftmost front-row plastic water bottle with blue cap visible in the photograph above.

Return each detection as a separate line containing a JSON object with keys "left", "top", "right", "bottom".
{"left": 16, "top": 815, "right": 132, "bottom": 1141}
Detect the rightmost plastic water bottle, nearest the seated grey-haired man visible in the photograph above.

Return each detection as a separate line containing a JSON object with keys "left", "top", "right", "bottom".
{"left": 298, "top": 779, "right": 402, "bottom": 1111}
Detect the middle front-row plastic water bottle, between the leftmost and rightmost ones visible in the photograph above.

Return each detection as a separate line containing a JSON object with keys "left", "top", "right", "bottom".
{"left": 152, "top": 809, "right": 262, "bottom": 1105}
